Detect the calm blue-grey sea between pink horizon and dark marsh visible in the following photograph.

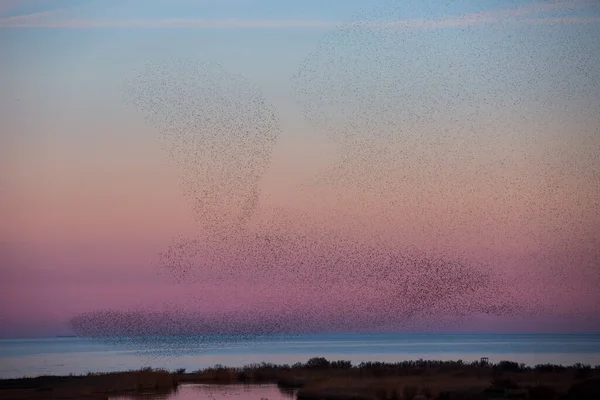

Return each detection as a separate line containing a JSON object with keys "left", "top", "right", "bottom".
{"left": 0, "top": 333, "right": 600, "bottom": 378}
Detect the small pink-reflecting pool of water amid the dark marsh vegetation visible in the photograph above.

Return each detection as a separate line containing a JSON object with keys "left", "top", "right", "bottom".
{"left": 110, "top": 384, "right": 295, "bottom": 400}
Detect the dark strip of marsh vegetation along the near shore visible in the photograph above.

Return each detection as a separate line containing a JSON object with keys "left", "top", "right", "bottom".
{"left": 0, "top": 358, "right": 600, "bottom": 400}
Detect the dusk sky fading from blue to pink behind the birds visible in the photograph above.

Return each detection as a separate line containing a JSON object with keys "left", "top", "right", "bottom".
{"left": 0, "top": 0, "right": 600, "bottom": 336}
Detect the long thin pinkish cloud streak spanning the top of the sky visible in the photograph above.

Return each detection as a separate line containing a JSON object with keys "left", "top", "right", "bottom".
{"left": 0, "top": 0, "right": 600, "bottom": 29}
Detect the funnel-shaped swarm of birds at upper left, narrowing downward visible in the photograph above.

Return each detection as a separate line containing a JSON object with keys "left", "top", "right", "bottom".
{"left": 127, "top": 59, "right": 280, "bottom": 236}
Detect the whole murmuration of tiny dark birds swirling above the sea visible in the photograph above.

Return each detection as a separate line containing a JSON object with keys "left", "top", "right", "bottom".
{"left": 72, "top": 0, "right": 596, "bottom": 352}
